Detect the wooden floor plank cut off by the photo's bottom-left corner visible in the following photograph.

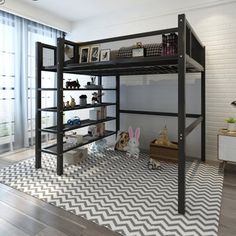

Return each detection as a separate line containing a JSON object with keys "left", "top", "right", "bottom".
{"left": 0, "top": 218, "right": 29, "bottom": 236}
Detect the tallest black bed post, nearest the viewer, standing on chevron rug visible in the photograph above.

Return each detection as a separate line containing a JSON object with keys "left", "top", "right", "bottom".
{"left": 178, "top": 14, "right": 186, "bottom": 214}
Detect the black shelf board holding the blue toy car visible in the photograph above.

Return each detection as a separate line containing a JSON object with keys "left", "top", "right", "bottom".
{"left": 41, "top": 117, "right": 116, "bottom": 134}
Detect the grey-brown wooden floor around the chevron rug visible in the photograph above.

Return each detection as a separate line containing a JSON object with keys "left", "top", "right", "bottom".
{"left": 0, "top": 149, "right": 236, "bottom": 236}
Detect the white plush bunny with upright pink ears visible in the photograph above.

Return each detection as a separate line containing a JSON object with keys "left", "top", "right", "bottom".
{"left": 124, "top": 127, "right": 140, "bottom": 158}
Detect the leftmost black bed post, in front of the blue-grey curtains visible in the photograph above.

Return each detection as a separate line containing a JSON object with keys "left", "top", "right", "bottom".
{"left": 35, "top": 42, "right": 43, "bottom": 169}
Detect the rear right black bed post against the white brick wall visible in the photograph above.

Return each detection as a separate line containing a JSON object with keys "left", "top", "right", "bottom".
{"left": 201, "top": 47, "right": 206, "bottom": 161}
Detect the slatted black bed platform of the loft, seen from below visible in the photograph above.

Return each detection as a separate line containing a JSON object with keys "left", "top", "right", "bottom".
{"left": 42, "top": 55, "right": 204, "bottom": 76}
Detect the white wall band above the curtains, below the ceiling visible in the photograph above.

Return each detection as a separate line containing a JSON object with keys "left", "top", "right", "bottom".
{"left": 0, "top": 0, "right": 71, "bottom": 32}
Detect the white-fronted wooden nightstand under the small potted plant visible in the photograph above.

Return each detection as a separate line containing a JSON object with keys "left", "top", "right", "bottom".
{"left": 217, "top": 130, "right": 236, "bottom": 167}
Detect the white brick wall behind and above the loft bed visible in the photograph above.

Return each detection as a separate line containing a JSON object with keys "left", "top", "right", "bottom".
{"left": 70, "top": 0, "right": 236, "bottom": 159}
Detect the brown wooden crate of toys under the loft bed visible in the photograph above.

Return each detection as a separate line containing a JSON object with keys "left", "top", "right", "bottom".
{"left": 150, "top": 140, "right": 179, "bottom": 162}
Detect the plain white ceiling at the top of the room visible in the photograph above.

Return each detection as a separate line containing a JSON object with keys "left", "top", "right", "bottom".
{"left": 17, "top": 0, "right": 147, "bottom": 21}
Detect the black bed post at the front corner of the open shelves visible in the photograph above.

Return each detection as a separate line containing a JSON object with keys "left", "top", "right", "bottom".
{"left": 57, "top": 38, "right": 64, "bottom": 175}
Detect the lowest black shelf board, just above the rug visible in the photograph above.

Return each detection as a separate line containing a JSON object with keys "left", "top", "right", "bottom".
{"left": 41, "top": 130, "right": 116, "bottom": 155}
